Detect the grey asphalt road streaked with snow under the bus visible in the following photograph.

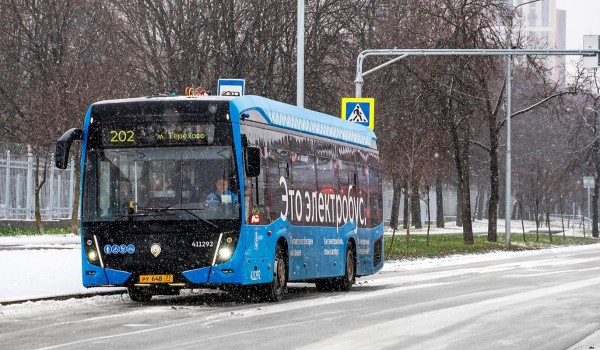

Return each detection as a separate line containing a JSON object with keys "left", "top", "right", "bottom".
{"left": 0, "top": 245, "right": 600, "bottom": 349}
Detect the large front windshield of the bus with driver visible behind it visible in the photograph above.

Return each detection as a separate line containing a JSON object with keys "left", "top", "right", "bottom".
{"left": 83, "top": 145, "right": 240, "bottom": 221}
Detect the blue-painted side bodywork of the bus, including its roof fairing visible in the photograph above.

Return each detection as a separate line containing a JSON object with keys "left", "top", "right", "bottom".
{"left": 230, "top": 95, "right": 383, "bottom": 284}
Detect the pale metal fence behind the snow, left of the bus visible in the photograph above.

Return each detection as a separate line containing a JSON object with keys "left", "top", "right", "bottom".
{"left": 0, "top": 150, "right": 76, "bottom": 220}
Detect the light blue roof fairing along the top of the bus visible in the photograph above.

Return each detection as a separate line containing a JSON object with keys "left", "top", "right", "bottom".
{"left": 230, "top": 95, "right": 377, "bottom": 149}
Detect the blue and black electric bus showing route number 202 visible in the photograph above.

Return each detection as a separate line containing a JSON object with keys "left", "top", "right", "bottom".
{"left": 55, "top": 92, "right": 384, "bottom": 301}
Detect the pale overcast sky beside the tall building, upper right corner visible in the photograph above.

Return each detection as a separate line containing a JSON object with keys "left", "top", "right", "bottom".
{"left": 556, "top": 0, "right": 600, "bottom": 49}
